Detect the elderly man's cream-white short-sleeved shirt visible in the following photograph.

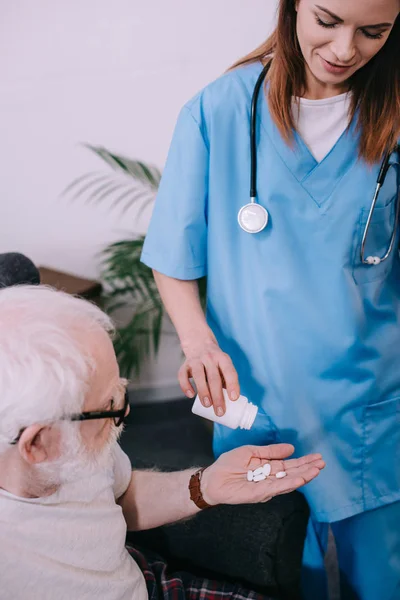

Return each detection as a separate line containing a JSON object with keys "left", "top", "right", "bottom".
{"left": 0, "top": 446, "right": 148, "bottom": 600}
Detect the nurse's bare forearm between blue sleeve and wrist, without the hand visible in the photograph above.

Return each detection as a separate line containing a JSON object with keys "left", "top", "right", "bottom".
{"left": 153, "top": 271, "right": 216, "bottom": 353}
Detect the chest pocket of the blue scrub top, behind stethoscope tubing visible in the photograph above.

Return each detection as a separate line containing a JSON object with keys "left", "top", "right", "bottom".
{"left": 353, "top": 194, "right": 398, "bottom": 284}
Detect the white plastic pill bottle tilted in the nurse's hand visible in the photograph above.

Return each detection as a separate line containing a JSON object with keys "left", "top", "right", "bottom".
{"left": 192, "top": 389, "right": 258, "bottom": 429}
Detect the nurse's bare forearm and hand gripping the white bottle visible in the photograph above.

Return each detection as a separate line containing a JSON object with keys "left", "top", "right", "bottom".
{"left": 153, "top": 271, "right": 240, "bottom": 416}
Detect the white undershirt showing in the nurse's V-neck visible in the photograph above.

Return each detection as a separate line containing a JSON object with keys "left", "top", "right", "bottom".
{"left": 292, "top": 92, "right": 350, "bottom": 162}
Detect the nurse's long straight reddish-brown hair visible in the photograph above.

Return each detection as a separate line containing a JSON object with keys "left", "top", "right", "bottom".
{"left": 232, "top": 0, "right": 400, "bottom": 164}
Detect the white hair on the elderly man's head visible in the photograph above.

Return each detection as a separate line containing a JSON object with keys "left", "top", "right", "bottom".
{"left": 0, "top": 285, "right": 114, "bottom": 453}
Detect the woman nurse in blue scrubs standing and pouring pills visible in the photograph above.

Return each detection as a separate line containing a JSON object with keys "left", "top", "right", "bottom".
{"left": 142, "top": 0, "right": 400, "bottom": 600}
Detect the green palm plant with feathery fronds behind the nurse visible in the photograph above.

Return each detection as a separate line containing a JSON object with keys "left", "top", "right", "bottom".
{"left": 64, "top": 144, "right": 206, "bottom": 377}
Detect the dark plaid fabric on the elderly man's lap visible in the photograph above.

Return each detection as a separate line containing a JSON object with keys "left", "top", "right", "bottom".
{"left": 127, "top": 546, "right": 276, "bottom": 600}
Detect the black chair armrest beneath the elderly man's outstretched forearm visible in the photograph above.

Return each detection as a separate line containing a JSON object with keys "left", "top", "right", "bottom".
{"left": 127, "top": 492, "right": 309, "bottom": 600}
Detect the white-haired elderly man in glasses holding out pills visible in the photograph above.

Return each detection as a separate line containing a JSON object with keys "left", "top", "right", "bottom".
{"left": 0, "top": 285, "right": 324, "bottom": 600}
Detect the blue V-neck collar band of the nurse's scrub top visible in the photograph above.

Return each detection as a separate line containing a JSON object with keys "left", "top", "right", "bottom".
{"left": 257, "top": 76, "right": 359, "bottom": 206}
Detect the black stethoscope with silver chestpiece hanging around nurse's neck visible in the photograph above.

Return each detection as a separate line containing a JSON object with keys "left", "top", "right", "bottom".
{"left": 238, "top": 63, "right": 400, "bottom": 265}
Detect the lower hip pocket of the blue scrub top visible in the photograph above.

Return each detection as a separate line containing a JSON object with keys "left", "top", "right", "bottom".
{"left": 364, "top": 398, "right": 400, "bottom": 510}
